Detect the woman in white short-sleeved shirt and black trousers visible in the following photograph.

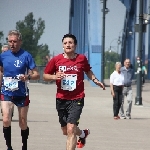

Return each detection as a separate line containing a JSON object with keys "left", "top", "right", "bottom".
{"left": 110, "top": 62, "right": 124, "bottom": 120}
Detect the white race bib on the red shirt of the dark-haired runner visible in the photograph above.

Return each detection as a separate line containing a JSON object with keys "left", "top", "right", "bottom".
{"left": 61, "top": 74, "right": 77, "bottom": 91}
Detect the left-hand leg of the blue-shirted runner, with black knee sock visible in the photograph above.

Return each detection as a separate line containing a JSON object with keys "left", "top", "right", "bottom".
{"left": 1, "top": 101, "right": 13, "bottom": 150}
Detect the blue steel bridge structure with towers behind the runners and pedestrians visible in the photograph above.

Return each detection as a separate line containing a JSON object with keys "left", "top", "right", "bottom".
{"left": 69, "top": 0, "right": 150, "bottom": 86}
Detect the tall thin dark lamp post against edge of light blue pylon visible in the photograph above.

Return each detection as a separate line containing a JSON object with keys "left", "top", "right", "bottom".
{"left": 100, "top": 0, "right": 109, "bottom": 83}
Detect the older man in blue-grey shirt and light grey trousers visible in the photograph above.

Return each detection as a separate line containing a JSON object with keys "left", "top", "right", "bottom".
{"left": 120, "top": 59, "right": 134, "bottom": 119}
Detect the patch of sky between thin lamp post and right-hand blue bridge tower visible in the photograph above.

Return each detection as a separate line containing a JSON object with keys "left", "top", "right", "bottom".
{"left": 105, "top": 0, "right": 126, "bottom": 51}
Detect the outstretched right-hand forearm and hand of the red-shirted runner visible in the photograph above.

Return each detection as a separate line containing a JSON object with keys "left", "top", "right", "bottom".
{"left": 85, "top": 70, "right": 105, "bottom": 90}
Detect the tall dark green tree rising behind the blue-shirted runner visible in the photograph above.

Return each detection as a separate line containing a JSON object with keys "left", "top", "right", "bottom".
{"left": 16, "top": 12, "right": 49, "bottom": 65}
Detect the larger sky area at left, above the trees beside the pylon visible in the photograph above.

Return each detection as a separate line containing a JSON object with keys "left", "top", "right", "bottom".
{"left": 0, "top": 0, "right": 70, "bottom": 53}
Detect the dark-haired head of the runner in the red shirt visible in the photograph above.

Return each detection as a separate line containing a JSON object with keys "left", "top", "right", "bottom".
{"left": 62, "top": 34, "right": 77, "bottom": 54}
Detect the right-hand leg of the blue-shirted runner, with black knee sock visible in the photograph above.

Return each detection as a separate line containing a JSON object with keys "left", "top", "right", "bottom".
{"left": 18, "top": 106, "right": 29, "bottom": 150}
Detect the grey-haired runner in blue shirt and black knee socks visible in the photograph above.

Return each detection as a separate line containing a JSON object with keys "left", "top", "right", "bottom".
{"left": 0, "top": 30, "right": 39, "bottom": 150}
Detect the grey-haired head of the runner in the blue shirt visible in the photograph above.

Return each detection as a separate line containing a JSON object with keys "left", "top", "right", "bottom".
{"left": 8, "top": 30, "right": 22, "bottom": 52}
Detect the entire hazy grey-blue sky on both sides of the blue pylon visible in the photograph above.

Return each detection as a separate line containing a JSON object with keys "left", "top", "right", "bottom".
{"left": 0, "top": 0, "right": 125, "bottom": 54}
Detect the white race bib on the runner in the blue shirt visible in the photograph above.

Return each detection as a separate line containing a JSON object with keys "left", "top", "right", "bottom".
{"left": 4, "top": 77, "right": 18, "bottom": 91}
